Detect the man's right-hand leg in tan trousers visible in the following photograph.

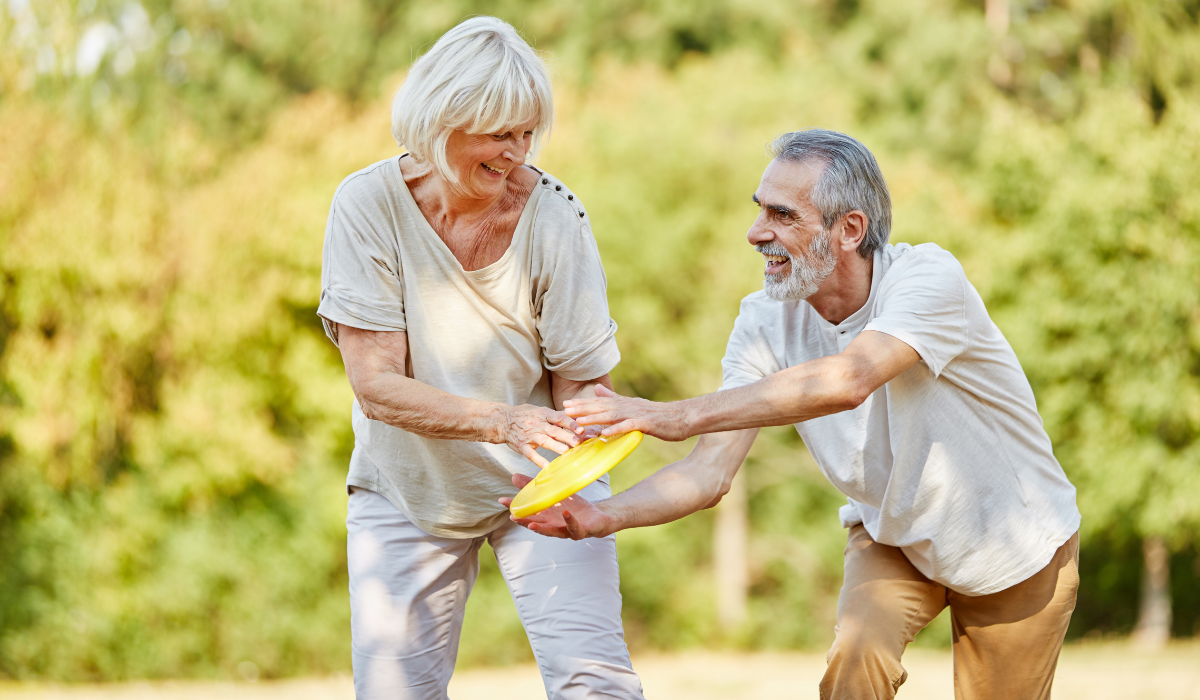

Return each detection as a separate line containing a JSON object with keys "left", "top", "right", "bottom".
{"left": 949, "top": 533, "right": 1079, "bottom": 700}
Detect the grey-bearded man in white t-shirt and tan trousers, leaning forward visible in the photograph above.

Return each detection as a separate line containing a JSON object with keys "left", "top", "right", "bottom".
{"left": 515, "top": 130, "right": 1079, "bottom": 700}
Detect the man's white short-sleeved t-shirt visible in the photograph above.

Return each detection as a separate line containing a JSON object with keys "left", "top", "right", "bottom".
{"left": 721, "top": 244, "right": 1080, "bottom": 596}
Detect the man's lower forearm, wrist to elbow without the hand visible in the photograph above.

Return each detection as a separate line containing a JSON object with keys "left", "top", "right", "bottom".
{"left": 596, "top": 430, "right": 758, "bottom": 534}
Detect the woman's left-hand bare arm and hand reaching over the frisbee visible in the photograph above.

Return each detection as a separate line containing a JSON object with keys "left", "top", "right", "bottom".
{"left": 337, "top": 324, "right": 583, "bottom": 467}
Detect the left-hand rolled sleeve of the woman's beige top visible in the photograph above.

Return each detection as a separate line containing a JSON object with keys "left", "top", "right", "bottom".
{"left": 317, "top": 173, "right": 407, "bottom": 345}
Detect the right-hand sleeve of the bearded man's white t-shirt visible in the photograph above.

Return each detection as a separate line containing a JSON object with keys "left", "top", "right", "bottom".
{"left": 863, "top": 252, "right": 967, "bottom": 377}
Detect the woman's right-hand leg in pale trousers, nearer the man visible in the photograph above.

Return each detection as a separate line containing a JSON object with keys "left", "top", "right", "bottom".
{"left": 488, "top": 483, "right": 642, "bottom": 700}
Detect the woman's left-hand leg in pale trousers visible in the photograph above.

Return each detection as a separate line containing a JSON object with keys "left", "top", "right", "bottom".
{"left": 346, "top": 487, "right": 484, "bottom": 700}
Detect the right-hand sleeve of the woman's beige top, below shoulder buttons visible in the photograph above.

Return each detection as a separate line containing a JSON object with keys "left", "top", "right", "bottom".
{"left": 533, "top": 191, "right": 620, "bottom": 382}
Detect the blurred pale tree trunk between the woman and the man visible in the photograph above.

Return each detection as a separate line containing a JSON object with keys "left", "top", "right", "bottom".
{"left": 713, "top": 472, "right": 750, "bottom": 632}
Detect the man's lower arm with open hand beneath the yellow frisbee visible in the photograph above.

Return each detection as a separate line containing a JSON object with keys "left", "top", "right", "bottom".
{"left": 500, "top": 430, "right": 758, "bottom": 539}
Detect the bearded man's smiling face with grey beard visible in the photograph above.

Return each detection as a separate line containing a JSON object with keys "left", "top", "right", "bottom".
{"left": 746, "top": 161, "right": 838, "bottom": 301}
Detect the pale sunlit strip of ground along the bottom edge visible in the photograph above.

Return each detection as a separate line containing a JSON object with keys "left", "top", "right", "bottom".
{"left": 0, "top": 642, "right": 1200, "bottom": 700}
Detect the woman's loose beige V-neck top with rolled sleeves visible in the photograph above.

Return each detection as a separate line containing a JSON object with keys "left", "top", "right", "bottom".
{"left": 317, "top": 157, "right": 620, "bottom": 538}
